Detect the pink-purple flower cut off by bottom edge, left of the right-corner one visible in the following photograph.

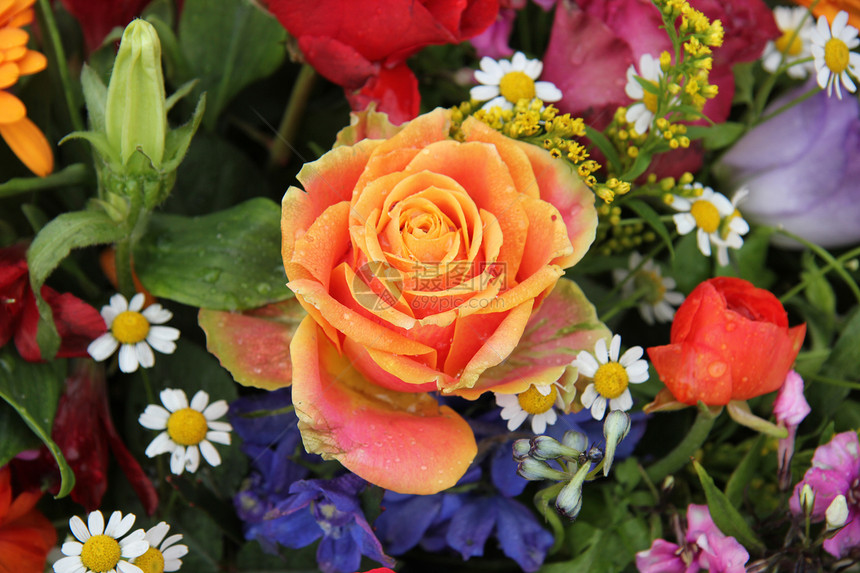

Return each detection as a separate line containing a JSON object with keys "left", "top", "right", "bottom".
{"left": 636, "top": 504, "right": 750, "bottom": 573}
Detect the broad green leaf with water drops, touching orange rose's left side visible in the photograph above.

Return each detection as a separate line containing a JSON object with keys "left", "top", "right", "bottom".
{"left": 134, "top": 198, "right": 292, "bottom": 310}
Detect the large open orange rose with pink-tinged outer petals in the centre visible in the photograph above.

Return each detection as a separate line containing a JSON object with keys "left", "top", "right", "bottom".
{"left": 208, "top": 109, "right": 606, "bottom": 494}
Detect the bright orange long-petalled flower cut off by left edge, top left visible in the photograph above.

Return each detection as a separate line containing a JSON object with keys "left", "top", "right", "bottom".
{"left": 0, "top": 0, "right": 54, "bottom": 177}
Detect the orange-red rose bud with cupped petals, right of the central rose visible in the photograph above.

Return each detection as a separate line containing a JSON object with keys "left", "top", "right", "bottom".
{"left": 648, "top": 277, "right": 806, "bottom": 406}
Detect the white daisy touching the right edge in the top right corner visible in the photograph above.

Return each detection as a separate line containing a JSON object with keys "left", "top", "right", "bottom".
{"left": 810, "top": 10, "right": 860, "bottom": 99}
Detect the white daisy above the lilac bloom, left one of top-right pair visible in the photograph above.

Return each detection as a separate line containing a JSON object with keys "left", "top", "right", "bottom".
{"left": 761, "top": 6, "right": 814, "bottom": 79}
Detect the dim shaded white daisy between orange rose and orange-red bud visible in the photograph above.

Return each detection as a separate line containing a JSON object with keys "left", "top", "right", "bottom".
{"left": 612, "top": 251, "right": 684, "bottom": 324}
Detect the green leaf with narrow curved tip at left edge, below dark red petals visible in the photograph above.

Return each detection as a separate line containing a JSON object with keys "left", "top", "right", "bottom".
{"left": 0, "top": 353, "right": 75, "bottom": 498}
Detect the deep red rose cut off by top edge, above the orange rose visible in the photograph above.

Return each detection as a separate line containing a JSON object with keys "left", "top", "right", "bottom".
{"left": 268, "top": 0, "right": 499, "bottom": 123}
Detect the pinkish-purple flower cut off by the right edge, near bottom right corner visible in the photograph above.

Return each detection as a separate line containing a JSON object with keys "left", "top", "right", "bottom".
{"left": 789, "top": 431, "right": 860, "bottom": 559}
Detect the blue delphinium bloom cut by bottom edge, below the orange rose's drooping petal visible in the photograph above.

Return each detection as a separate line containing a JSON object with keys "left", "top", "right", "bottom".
{"left": 246, "top": 474, "right": 394, "bottom": 573}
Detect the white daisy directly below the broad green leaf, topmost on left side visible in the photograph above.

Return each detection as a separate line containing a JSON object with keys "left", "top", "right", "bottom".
{"left": 87, "top": 293, "right": 179, "bottom": 372}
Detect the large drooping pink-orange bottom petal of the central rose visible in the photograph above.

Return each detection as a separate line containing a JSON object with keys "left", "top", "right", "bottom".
{"left": 292, "top": 318, "right": 477, "bottom": 495}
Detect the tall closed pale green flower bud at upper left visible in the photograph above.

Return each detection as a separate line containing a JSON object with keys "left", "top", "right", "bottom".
{"left": 105, "top": 20, "right": 167, "bottom": 168}
